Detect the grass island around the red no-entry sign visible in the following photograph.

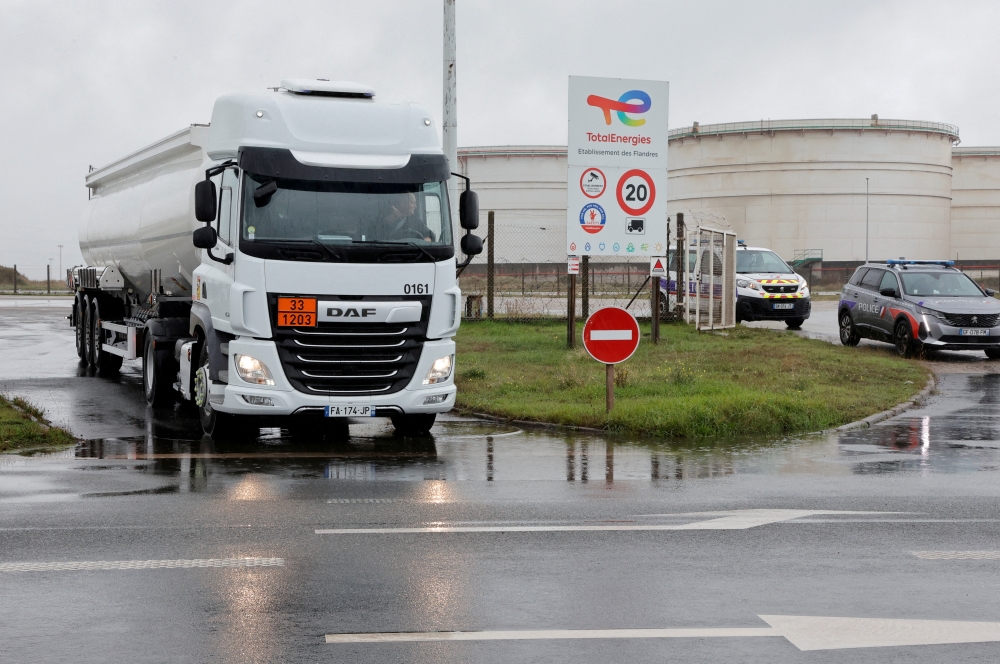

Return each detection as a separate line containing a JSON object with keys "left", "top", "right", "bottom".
{"left": 456, "top": 322, "right": 929, "bottom": 438}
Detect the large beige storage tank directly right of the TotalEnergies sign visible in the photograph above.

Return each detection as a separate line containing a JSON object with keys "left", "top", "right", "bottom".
{"left": 669, "top": 117, "right": 958, "bottom": 261}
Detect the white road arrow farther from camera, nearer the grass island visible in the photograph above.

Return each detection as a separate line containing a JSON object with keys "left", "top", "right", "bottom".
{"left": 316, "top": 510, "right": 886, "bottom": 535}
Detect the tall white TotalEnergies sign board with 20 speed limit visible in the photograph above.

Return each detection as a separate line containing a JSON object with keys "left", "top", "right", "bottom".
{"left": 566, "top": 76, "right": 670, "bottom": 256}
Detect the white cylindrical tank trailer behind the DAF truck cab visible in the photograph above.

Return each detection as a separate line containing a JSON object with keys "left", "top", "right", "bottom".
{"left": 80, "top": 126, "right": 211, "bottom": 301}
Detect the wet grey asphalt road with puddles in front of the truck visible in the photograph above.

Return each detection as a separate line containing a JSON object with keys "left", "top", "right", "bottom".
{"left": 0, "top": 300, "right": 1000, "bottom": 662}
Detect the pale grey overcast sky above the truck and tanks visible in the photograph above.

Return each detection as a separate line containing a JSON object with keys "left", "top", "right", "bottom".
{"left": 0, "top": 0, "right": 1000, "bottom": 278}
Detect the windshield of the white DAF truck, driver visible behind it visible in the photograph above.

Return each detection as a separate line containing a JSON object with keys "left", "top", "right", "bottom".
{"left": 240, "top": 173, "right": 454, "bottom": 262}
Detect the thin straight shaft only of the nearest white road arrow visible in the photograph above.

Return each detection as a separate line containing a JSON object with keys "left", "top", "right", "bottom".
{"left": 326, "top": 627, "right": 781, "bottom": 643}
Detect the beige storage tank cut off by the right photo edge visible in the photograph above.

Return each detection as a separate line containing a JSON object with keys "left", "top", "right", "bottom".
{"left": 949, "top": 147, "right": 1000, "bottom": 261}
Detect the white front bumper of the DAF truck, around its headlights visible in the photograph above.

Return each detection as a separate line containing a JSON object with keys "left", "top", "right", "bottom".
{"left": 217, "top": 337, "right": 457, "bottom": 417}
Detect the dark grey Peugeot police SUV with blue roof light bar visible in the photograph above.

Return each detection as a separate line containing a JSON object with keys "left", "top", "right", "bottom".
{"left": 837, "top": 260, "right": 1000, "bottom": 359}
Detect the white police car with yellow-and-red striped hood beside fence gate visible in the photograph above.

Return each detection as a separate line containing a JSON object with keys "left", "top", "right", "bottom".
{"left": 736, "top": 240, "right": 812, "bottom": 330}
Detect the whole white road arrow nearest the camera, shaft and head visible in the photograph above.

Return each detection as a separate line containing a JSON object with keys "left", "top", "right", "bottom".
{"left": 326, "top": 616, "right": 1000, "bottom": 650}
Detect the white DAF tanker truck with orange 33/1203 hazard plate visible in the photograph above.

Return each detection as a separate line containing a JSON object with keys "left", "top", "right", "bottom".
{"left": 71, "top": 80, "right": 482, "bottom": 437}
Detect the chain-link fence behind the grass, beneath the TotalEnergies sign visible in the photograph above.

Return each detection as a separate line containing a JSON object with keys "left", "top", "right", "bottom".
{"left": 460, "top": 213, "right": 652, "bottom": 321}
